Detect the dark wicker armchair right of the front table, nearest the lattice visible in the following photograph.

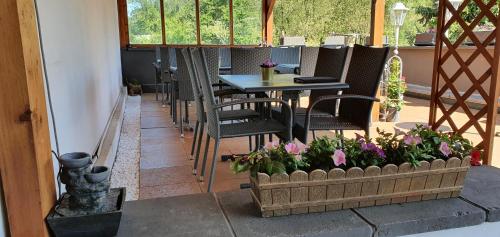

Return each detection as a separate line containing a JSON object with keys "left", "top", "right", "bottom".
{"left": 293, "top": 45, "right": 389, "bottom": 143}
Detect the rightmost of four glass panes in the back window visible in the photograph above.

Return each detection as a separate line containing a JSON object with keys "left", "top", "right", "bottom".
{"left": 233, "top": 0, "right": 262, "bottom": 45}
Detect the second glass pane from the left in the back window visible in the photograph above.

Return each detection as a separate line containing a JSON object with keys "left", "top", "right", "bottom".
{"left": 164, "top": 0, "right": 196, "bottom": 44}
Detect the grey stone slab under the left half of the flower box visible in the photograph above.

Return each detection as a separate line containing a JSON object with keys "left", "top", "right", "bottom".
{"left": 217, "top": 190, "right": 372, "bottom": 237}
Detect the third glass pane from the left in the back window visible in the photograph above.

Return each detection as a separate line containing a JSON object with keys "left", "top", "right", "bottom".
{"left": 200, "top": 0, "right": 229, "bottom": 44}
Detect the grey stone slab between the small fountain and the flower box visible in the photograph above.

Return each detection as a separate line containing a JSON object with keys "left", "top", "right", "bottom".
{"left": 117, "top": 194, "right": 231, "bottom": 237}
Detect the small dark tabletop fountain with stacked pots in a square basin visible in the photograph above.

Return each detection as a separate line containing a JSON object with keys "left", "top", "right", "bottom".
{"left": 47, "top": 152, "right": 125, "bottom": 237}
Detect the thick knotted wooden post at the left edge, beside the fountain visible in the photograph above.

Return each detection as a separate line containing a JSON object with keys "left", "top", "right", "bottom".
{"left": 0, "top": 0, "right": 56, "bottom": 237}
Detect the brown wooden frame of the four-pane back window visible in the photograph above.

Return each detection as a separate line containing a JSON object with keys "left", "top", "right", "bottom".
{"left": 121, "top": 0, "right": 267, "bottom": 48}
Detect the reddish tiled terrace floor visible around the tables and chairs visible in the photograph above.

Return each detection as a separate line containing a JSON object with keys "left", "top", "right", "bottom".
{"left": 139, "top": 94, "right": 500, "bottom": 199}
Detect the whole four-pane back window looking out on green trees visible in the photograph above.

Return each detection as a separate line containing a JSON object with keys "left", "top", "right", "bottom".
{"left": 124, "top": 0, "right": 263, "bottom": 45}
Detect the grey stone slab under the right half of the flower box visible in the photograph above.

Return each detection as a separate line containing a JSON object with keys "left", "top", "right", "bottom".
{"left": 355, "top": 198, "right": 486, "bottom": 237}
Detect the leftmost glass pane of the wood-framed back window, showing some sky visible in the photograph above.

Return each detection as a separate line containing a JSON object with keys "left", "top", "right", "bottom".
{"left": 127, "top": 0, "right": 162, "bottom": 44}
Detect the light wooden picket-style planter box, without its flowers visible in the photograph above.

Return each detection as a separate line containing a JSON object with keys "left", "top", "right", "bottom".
{"left": 250, "top": 158, "right": 470, "bottom": 217}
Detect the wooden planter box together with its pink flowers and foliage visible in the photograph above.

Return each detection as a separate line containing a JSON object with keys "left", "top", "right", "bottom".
{"left": 231, "top": 126, "right": 481, "bottom": 217}
